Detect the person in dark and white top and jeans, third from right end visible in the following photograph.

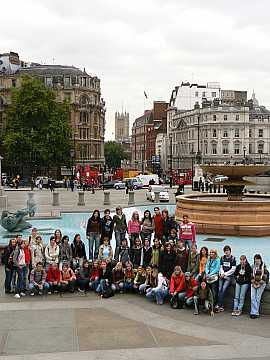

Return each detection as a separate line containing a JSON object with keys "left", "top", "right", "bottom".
{"left": 215, "top": 245, "right": 236, "bottom": 312}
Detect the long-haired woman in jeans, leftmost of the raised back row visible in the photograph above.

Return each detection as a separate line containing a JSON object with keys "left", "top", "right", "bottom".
{"left": 86, "top": 210, "right": 102, "bottom": 261}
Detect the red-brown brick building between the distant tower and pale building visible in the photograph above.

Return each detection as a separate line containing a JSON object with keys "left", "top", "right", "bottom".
{"left": 131, "top": 101, "right": 168, "bottom": 172}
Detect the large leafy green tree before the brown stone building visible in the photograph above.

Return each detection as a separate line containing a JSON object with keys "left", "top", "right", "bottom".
{"left": 3, "top": 76, "right": 71, "bottom": 176}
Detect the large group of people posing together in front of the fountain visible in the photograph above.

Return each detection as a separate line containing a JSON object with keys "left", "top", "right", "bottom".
{"left": 2, "top": 207, "right": 269, "bottom": 319}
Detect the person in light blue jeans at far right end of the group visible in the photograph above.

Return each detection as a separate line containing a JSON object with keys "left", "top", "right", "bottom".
{"left": 250, "top": 254, "right": 269, "bottom": 319}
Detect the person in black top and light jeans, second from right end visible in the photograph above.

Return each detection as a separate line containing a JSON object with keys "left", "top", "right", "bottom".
{"left": 232, "top": 255, "right": 251, "bottom": 316}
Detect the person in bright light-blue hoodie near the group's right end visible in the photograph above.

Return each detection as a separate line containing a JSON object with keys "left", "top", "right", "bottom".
{"left": 205, "top": 249, "right": 220, "bottom": 305}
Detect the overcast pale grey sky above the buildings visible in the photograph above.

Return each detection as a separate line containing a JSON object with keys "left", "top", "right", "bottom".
{"left": 0, "top": 0, "right": 270, "bottom": 139}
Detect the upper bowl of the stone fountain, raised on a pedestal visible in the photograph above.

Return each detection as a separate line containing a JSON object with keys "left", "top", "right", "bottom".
{"left": 201, "top": 164, "right": 270, "bottom": 179}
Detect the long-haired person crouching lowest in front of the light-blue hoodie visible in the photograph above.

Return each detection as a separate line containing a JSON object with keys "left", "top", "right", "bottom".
{"left": 193, "top": 279, "right": 214, "bottom": 316}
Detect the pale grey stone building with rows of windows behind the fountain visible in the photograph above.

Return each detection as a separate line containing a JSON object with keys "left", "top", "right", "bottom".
{"left": 168, "top": 100, "right": 270, "bottom": 169}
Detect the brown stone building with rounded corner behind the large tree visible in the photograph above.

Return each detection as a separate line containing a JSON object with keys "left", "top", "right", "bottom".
{"left": 0, "top": 53, "right": 106, "bottom": 167}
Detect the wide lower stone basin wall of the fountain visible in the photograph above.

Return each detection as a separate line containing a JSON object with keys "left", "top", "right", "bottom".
{"left": 175, "top": 193, "right": 270, "bottom": 236}
